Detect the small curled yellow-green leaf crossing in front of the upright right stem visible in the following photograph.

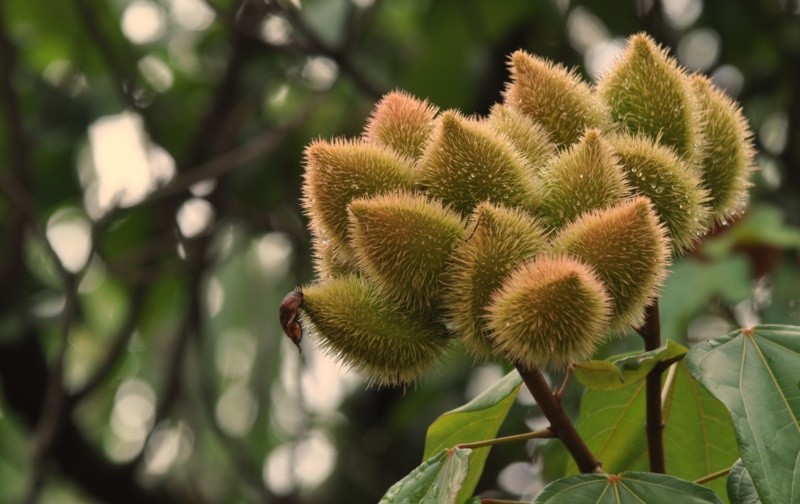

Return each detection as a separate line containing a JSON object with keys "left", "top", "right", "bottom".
{"left": 574, "top": 340, "right": 689, "bottom": 390}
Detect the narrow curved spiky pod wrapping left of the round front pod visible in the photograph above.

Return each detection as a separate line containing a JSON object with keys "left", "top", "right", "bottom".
{"left": 442, "top": 203, "right": 547, "bottom": 359}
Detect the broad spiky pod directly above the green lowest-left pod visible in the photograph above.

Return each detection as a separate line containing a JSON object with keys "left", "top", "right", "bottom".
{"left": 350, "top": 193, "right": 464, "bottom": 310}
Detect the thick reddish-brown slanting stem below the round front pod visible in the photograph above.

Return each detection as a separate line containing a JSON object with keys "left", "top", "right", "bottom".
{"left": 517, "top": 364, "right": 600, "bottom": 473}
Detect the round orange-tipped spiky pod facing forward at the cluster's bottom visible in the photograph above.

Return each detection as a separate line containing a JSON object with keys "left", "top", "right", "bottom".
{"left": 488, "top": 256, "right": 611, "bottom": 369}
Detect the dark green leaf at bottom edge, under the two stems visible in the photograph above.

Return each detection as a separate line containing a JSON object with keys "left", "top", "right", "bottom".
{"left": 534, "top": 472, "right": 721, "bottom": 504}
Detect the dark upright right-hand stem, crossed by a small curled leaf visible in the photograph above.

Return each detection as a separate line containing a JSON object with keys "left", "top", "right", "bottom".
{"left": 638, "top": 300, "right": 666, "bottom": 474}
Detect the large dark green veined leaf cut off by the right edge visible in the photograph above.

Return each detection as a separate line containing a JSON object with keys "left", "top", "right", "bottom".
{"left": 686, "top": 325, "right": 800, "bottom": 504}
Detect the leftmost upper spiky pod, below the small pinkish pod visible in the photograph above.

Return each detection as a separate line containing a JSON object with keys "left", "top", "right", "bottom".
{"left": 303, "top": 140, "right": 414, "bottom": 252}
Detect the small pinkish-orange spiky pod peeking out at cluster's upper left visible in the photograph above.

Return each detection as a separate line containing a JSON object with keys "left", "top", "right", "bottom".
{"left": 364, "top": 91, "right": 439, "bottom": 159}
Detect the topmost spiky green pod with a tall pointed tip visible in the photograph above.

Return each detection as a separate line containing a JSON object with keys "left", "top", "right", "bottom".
{"left": 597, "top": 33, "right": 701, "bottom": 161}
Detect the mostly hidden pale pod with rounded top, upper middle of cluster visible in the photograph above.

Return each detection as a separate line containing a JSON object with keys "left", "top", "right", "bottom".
{"left": 488, "top": 103, "right": 556, "bottom": 171}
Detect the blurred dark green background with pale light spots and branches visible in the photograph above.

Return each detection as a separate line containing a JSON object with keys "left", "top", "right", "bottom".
{"left": 0, "top": 0, "right": 800, "bottom": 504}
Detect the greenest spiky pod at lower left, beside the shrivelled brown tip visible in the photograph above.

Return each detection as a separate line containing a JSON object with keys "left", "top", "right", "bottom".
{"left": 301, "top": 276, "right": 448, "bottom": 385}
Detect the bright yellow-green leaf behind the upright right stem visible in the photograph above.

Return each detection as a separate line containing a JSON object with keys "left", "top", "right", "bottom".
{"left": 567, "top": 363, "right": 739, "bottom": 495}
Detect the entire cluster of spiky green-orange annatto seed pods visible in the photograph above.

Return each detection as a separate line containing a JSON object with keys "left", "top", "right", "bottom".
{"left": 294, "top": 35, "right": 753, "bottom": 385}
